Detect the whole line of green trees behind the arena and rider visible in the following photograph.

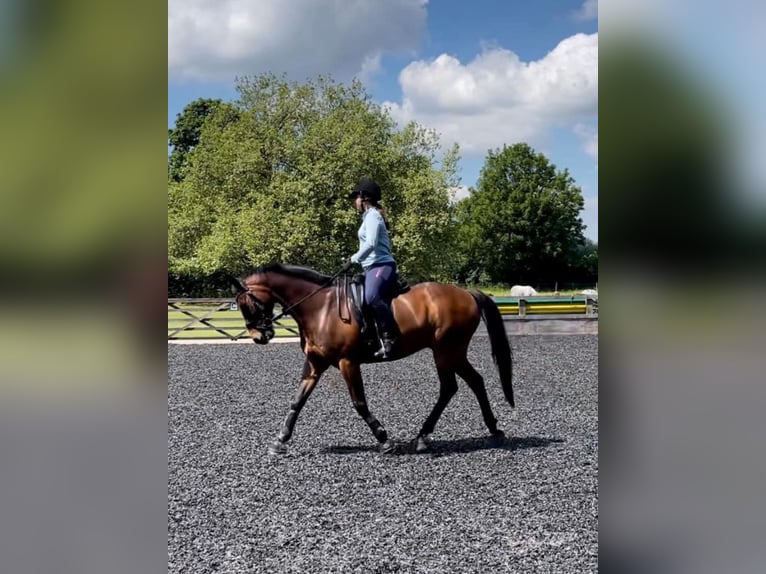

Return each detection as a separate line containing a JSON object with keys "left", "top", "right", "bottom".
{"left": 168, "top": 74, "right": 598, "bottom": 296}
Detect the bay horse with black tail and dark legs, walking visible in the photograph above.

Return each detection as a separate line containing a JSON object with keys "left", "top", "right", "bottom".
{"left": 230, "top": 264, "right": 515, "bottom": 455}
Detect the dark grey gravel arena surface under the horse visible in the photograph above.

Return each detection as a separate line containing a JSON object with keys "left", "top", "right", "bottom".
{"left": 168, "top": 334, "right": 598, "bottom": 574}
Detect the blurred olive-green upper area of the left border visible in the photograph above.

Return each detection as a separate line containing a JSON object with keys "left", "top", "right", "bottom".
{"left": 0, "top": 0, "right": 167, "bottom": 284}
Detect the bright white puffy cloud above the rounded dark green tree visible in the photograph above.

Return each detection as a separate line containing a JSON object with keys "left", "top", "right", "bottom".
{"left": 385, "top": 34, "right": 598, "bottom": 159}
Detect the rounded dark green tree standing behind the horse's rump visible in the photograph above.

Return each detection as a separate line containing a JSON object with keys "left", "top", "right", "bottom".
{"left": 456, "top": 143, "right": 584, "bottom": 283}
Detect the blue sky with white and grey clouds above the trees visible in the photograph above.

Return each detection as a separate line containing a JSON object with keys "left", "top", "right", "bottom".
{"left": 168, "top": 0, "right": 598, "bottom": 241}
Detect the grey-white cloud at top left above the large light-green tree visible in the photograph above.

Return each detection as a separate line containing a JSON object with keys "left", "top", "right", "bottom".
{"left": 168, "top": 0, "right": 427, "bottom": 81}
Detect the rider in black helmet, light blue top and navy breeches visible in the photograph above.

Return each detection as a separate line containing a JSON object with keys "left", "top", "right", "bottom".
{"left": 345, "top": 178, "right": 399, "bottom": 359}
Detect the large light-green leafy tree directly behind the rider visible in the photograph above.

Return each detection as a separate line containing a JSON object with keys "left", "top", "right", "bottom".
{"left": 168, "top": 74, "right": 457, "bottom": 277}
